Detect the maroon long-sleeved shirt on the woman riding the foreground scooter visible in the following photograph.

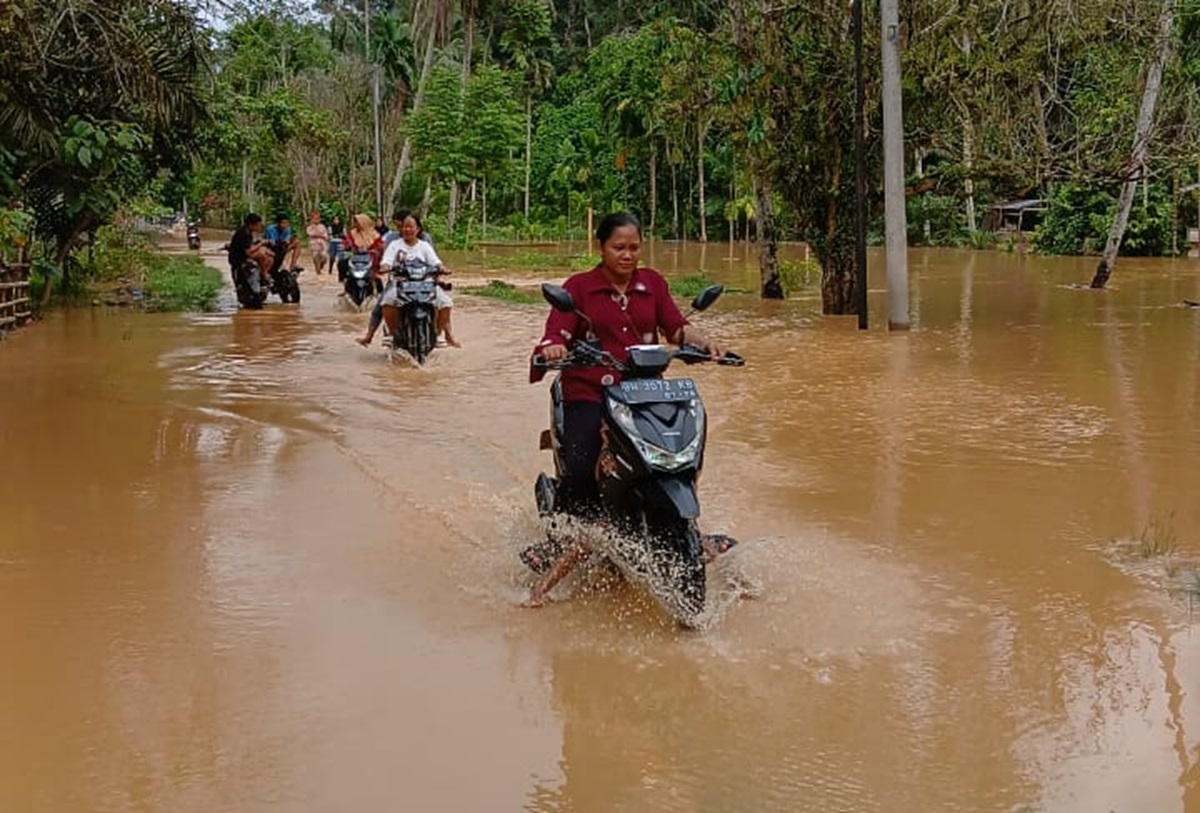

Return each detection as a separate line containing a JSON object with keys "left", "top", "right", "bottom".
{"left": 529, "top": 265, "right": 688, "bottom": 402}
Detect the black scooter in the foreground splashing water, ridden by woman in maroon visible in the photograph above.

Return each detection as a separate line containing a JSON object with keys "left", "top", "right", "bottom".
{"left": 533, "top": 283, "right": 745, "bottom": 627}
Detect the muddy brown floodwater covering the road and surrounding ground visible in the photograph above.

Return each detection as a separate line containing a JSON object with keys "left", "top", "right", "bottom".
{"left": 0, "top": 243, "right": 1200, "bottom": 813}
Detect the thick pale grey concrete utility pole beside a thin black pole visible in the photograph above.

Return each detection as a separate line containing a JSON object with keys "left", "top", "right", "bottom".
{"left": 880, "top": 0, "right": 908, "bottom": 330}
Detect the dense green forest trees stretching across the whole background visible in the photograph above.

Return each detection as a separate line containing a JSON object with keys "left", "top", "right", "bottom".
{"left": 0, "top": 0, "right": 1200, "bottom": 312}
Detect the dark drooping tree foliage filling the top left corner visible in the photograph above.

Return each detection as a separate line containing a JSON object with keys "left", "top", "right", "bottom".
{"left": 0, "top": 0, "right": 208, "bottom": 271}
